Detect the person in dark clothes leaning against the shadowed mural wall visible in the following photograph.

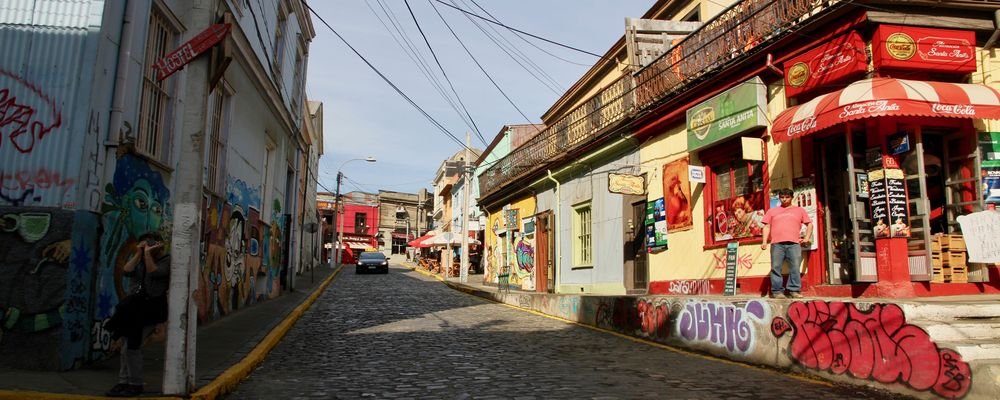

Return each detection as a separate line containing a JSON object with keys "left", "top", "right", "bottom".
{"left": 105, "top": 234, "right": 170, "bottom": 397}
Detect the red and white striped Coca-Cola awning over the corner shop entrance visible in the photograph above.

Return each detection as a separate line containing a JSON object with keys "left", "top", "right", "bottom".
{"left": 771, "top": 78, "right": 1000, "bottom": 143}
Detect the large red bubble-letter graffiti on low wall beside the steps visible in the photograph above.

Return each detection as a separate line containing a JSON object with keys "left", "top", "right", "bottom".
{"left": 771, "top": 301, "right": 972, "bottom": 398}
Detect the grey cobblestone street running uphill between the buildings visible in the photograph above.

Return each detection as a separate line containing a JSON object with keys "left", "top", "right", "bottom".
{"left": 228, "top": 266, "right": 897, "bottom": 400}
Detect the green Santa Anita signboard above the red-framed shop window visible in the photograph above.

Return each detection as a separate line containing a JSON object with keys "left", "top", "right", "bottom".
{"left": 687, "top": 76, "right": 768, "bottom": 151}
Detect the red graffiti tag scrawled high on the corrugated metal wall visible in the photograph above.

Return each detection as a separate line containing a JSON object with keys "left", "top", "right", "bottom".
{"left": 0, "top": 69, "right": 62, "bottom": 153}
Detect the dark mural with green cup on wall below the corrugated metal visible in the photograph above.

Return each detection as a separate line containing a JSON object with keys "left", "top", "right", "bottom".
{"left": 0, "top": 207, "right": 74, "bottom": 370}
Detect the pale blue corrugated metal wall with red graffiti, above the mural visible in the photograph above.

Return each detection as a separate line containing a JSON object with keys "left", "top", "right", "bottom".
{"left": 0, "top": 0, "right": 97, "bottom": 208}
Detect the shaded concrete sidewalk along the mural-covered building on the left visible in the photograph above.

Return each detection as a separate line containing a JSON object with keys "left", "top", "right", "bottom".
{"left": 0, "top": 267, "right": 339, "bottom": 399}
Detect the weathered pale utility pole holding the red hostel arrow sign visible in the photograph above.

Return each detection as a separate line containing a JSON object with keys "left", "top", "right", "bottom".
{"left": 164, "top": 0, "right": 211, "bottom": 395}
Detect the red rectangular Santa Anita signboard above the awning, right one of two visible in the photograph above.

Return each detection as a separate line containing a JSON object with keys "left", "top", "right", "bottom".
{"left": 872, "top": 25, "right": 976, "bottom": 73}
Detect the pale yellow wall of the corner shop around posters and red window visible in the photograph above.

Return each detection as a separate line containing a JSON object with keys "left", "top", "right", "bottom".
{"left": 639, "top": 81, "right": 801, "bottom": 282}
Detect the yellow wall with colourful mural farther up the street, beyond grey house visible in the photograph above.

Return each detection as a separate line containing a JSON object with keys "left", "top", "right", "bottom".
{"left": 483, "top": 196, "right": 538, "bottom": 290}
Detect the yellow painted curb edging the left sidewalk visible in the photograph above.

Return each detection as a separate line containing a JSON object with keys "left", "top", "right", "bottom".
{"left": 191, "top": 265, "right": 344, "bottom": 400}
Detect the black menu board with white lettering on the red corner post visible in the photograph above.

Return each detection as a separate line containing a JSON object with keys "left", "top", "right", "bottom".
{"left": 868, "top": 168, "right": 910, "bottom": 239}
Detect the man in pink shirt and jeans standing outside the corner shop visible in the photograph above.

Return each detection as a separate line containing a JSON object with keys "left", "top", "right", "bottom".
{"left": 760, "top": 188, "right": 812, "bottom": 299}
